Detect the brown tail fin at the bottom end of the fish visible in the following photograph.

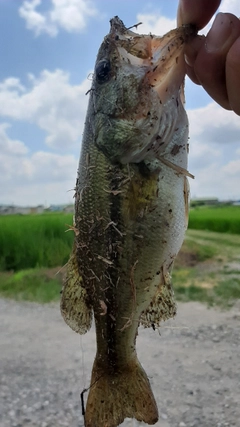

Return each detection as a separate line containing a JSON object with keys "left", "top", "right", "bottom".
{"left": 85, "top": 358, "right": 158, "bottom": 427}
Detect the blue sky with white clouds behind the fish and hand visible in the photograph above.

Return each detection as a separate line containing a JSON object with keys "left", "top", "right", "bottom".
{"left": 0, "top": 0, "right": 240, "bottom": 205}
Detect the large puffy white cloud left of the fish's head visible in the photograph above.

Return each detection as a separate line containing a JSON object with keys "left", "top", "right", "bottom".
{"left": 0, "top": 70, "right": 90, "bottom": 149}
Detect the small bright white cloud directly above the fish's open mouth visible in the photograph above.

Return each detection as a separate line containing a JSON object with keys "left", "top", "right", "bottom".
{"left": 137, "top": 12, "right": 176, "bottom": 36}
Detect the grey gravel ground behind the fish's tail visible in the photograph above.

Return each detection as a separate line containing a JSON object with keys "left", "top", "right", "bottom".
{"left": 0, "top": 300, "right": 240, "bottom": 427}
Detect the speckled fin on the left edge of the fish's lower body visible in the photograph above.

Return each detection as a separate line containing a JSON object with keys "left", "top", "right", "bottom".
{"left": 60, "top": 250, "right": 92, "bottom": 334}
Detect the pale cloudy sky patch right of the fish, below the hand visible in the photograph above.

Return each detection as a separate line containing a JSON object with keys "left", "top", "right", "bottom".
{"left": 188, "top": 103, "right": 240, "bottom": 200}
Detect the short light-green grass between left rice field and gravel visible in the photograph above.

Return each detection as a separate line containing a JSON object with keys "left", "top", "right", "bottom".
{"left": 0, "top": 268, "right": 61, "bottom": 303}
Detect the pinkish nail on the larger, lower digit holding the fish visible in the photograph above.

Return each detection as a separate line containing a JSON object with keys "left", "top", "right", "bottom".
{"left": 205, "top": 13, "right": 233, "bottom": 52}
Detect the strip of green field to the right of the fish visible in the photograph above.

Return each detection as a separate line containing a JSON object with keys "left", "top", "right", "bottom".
{"left": 189, "top": 205, "right": 240, "bottom": 234}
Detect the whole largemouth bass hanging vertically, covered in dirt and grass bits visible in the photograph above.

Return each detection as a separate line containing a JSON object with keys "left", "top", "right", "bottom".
{"left": 61, "top": 17, "right": 193, "bottom": 427}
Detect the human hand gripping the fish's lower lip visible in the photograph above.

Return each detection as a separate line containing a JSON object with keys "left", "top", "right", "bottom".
{"left": 178, "top": 0, "right": 240, "bottom": 115}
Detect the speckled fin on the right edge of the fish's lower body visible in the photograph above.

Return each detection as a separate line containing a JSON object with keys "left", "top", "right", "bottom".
{"left": 140, "top": 273, "right": 177, "bottom": 328}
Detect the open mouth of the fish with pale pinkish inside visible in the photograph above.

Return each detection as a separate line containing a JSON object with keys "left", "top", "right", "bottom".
{"left": 110, "top": 17, "right": 197, "bottom": 104}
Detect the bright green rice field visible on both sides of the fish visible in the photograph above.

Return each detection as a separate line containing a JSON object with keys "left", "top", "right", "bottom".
{"left": 0, "top": 206, "right": 240, "bottom": 271}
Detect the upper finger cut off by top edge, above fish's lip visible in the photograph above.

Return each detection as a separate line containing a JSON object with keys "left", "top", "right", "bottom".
{"left": 177, "top": 0, "right": 221, "bottom": 30}
